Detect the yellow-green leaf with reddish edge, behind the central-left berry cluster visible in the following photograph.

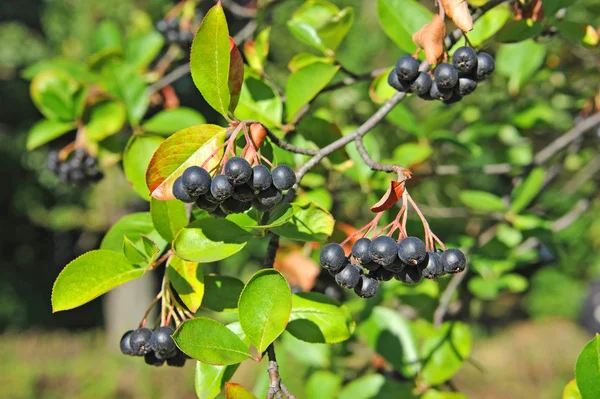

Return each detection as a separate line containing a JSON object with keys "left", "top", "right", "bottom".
{"left": 146, "top": 125, "right": 227, "bottom": 200}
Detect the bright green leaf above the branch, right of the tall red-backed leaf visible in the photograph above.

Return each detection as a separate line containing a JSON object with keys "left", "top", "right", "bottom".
{"left": 285, "top": 62, "right": 340, "bottom": 121}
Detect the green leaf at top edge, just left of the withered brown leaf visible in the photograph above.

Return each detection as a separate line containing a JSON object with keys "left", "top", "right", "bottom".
{"left": 377, "top": 0, "right": 434, "bottom": 53}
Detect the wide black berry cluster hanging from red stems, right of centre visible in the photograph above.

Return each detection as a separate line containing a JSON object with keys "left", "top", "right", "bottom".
{"left": 319, "top": 236, "right": 467, "bottom": 298}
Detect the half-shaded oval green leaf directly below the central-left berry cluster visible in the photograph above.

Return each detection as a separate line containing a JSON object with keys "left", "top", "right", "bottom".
{"left": 173, "top": 218, "right": 252, "bottom": 263}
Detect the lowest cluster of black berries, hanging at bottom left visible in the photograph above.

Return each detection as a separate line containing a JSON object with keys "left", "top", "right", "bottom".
{"left": 120, "top": 326, "right": 189, "bottom": 367}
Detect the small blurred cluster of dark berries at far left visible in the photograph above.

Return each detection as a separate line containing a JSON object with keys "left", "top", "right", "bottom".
{"left": 46, "top": 148, "right": 103, "bottom": 184}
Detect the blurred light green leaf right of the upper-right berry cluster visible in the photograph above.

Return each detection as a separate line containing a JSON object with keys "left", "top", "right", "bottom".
{"left": 496, "top": 39, "right": 546, "bottom": 95}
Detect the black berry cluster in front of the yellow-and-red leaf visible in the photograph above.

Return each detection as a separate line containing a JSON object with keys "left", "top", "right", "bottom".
{"left": 173, "top": 157, "right": 296, "bottom": 217}
